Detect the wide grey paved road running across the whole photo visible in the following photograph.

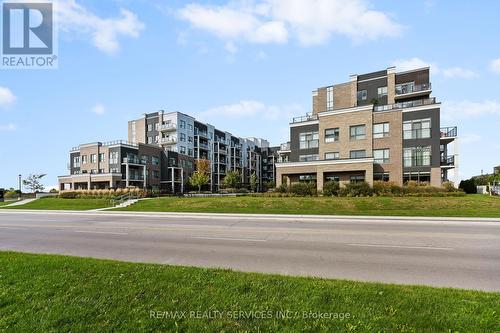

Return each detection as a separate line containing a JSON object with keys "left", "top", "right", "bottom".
{"left": 0, "top": 210, "right": 500, "bottom": 291}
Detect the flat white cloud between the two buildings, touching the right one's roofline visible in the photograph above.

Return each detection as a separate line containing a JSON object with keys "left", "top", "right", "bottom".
{"left": 200, "top": 100, "right": 303, "bottom": 120}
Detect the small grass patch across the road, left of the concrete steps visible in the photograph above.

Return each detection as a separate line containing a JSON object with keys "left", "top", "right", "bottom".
{"left": 3, "top": 197, "right": 111, "bottom": 210}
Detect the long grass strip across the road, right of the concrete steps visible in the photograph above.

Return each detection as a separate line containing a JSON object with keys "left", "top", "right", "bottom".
{"left": 118, "top": 194, "right": 500, "bottom": 217}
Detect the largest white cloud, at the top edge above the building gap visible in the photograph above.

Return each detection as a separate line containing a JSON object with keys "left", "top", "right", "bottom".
{"left": 178, "top": 0, "right": 403, "bottom": 46}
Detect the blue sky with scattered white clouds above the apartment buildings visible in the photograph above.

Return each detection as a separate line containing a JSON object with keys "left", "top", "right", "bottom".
{"left": 0, "top": 0, "right": 500, "bottom": 188}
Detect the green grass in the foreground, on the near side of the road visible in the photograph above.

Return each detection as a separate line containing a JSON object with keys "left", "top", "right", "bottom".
{"left": 0, "top": 252, "right": 500, "bottom": 332}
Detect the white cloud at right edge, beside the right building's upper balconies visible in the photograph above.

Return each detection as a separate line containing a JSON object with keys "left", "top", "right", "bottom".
{"left": 442, "top": 100, "right": 500, "bottom": 120}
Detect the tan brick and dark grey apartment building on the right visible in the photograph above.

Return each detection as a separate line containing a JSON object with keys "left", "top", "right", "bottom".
{"left": 276, "top": 67, "right": 458, "bottom": 189}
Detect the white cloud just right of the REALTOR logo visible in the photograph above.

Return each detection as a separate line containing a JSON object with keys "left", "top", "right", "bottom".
{"left": 54, "top": 0, "right": 144, "bottom": 54}
